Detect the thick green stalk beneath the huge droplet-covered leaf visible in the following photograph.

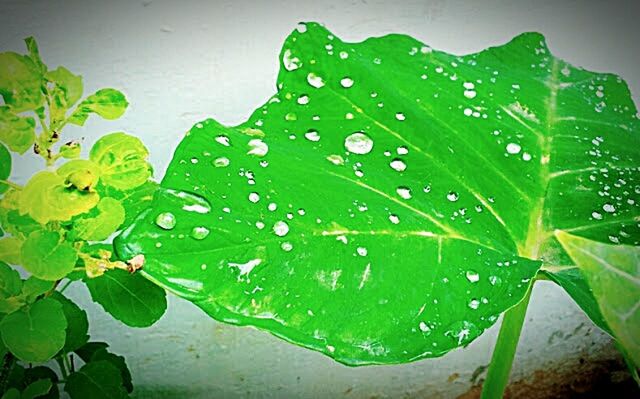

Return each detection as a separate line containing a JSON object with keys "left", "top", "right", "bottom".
{"left": 480, "top": 284, "right": 533, "bottom": 399}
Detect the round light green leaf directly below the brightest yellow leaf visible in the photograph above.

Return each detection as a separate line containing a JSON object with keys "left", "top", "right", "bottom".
{"left": 22, "top": 231, "right": 78, "bottom": 281}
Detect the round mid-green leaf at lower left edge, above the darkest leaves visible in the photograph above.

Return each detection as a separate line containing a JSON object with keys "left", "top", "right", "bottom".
{"left": 0, "top": 298, "right": 67, "bottom": 362}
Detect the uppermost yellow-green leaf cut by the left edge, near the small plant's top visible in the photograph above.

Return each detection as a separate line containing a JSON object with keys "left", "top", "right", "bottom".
{"left": 0, "top": 52, "right": 44, "bottom": 112}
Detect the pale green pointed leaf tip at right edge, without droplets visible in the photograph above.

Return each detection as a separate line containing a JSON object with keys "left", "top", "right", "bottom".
{"left": 556, "top": 231, "right": 640, "bottom": 367}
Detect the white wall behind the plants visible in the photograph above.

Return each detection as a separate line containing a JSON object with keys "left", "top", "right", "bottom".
{"left": 0, "top": 0, "right": 640, "bottom": 398}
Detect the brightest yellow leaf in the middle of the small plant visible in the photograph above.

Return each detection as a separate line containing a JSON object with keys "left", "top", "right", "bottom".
{"left": 20, "top": 171, "right": 99, "bottom": 224}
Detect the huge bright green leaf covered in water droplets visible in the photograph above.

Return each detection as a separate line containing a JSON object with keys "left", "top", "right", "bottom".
{"left": 116, "top": 24, "right": 640, "bottom": 365}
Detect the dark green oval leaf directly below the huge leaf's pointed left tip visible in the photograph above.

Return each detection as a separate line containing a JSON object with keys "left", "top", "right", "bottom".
{"left": 85, "top": 269, "right": 167, "bottom": 327}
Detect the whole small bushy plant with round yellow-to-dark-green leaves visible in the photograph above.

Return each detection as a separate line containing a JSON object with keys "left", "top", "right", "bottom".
{"left": 0, "top": 38, "right": 166, "bottom": 399}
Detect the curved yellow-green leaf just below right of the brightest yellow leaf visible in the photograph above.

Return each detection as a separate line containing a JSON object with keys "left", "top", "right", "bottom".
{"left": 71, "top": 197, "right": 125, "bottom": 241}
